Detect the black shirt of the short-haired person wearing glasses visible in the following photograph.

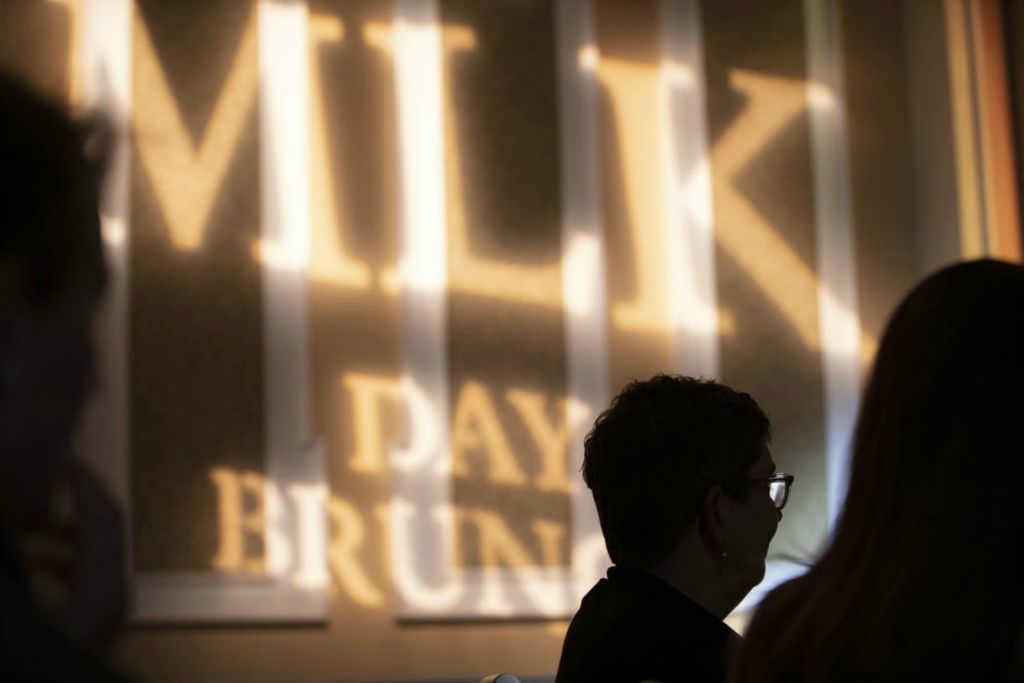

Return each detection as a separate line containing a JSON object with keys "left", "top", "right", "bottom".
{"left": 555, "top": 566, "right": 739, "bottom": 683}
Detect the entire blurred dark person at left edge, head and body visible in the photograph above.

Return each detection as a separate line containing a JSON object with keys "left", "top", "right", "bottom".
{"left": 0, "top": 74, "right": 125, "bottom": 681}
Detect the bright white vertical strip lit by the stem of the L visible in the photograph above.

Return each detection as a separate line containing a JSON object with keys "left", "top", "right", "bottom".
{"left": 390, "top": 0, "right": 462, "bottom": 616}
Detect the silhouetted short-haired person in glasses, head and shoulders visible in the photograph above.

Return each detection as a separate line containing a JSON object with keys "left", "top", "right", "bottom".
{"left": 556, "top": 375, "right": 793, "bottom": 683}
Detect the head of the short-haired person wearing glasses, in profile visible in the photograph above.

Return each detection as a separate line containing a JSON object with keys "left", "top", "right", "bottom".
{"left": 584, "top": 375, "right": 788, "bottom": 616}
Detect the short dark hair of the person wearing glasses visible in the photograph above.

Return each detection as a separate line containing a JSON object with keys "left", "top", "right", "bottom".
{"left": 583, "top": 375, "right": 771, "bottom": 568}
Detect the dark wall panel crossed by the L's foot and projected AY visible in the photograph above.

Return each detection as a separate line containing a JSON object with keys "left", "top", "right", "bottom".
{"left": 441, "top": 0, "right": 569, "bottom": 566}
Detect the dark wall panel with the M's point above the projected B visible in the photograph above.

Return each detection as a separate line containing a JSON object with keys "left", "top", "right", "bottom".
{"left": 129, "top": 0, "right": 263, "bottom": 571}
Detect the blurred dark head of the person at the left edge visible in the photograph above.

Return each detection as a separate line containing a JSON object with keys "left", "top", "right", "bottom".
{"left": 0, "top": 74, "right": 105, "bottom": 525}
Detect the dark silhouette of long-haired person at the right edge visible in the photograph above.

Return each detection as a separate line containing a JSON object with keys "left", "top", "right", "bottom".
{"left": 731, "top": 260, "right": 1024, "bottom": 681}
